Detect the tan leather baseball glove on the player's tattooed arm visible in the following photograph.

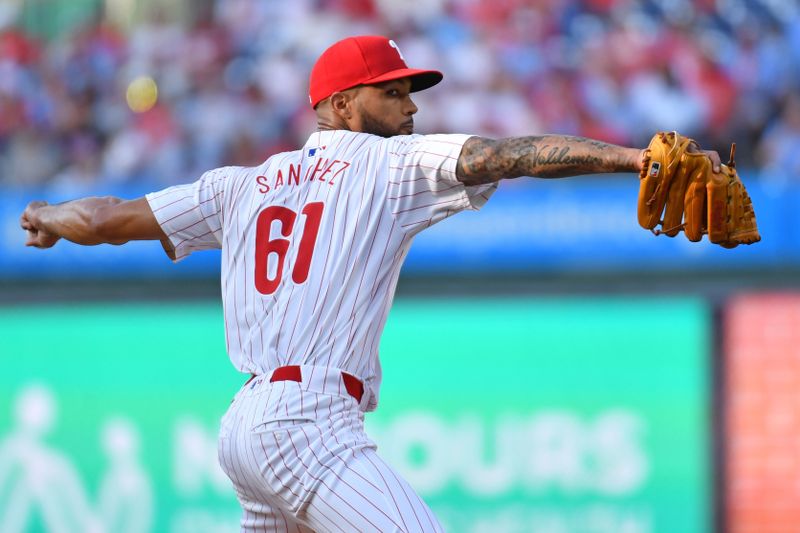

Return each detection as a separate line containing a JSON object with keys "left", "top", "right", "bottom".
{"left": 638, "top": 131, "right": 761, "bottom": 248}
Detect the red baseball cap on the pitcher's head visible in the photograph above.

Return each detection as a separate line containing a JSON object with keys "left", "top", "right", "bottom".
{"left": 308, "top": 35, "right": 444, "bottom": 108}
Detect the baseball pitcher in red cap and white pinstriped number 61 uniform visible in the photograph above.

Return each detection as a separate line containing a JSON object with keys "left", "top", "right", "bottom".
{"left": 21, "top": 36, "right": 757, "bottom": 532}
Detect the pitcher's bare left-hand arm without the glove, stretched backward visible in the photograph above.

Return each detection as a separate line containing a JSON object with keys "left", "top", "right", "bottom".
{"left": 20, "top": 196, "right": 167, "bottom": 248}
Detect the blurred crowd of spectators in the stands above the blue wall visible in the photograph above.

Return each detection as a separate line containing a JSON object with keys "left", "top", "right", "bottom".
{"left": 0, "top": 0, "right": 800, "bottom": 194}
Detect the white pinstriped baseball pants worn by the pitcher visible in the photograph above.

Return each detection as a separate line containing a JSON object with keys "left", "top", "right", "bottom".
{"left": 219, "top": 367, "right": 443, "bottom": 533}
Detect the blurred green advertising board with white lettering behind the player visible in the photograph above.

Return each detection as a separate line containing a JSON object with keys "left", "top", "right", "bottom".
{"left": 0, "top": 298, "right": 712, "bottom": 533}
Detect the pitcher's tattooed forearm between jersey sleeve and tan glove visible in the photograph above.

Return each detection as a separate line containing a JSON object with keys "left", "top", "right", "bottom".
{"left": 456, "top": 135, "right": 643, "bottom": 185}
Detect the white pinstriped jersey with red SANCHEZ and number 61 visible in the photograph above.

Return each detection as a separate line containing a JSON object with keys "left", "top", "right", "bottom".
{"left": 147, "top": 130, "right": 496, "bottom": 410}
